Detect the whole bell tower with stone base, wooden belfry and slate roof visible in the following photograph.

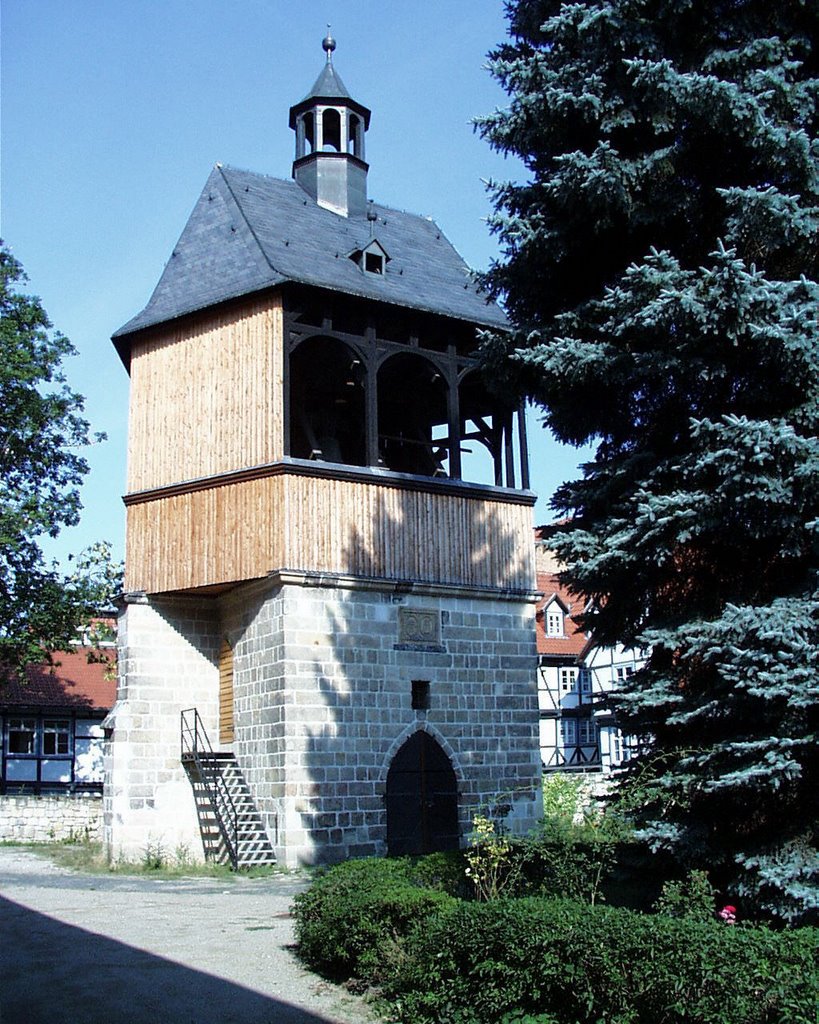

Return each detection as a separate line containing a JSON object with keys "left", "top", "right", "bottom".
{"left": 105, "top": 36, "right": 541, "bottom": 865}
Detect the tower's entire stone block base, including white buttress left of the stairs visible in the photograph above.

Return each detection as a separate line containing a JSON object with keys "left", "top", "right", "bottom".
{"left": 104, "top": 571, "right": 541, "bottom": 866}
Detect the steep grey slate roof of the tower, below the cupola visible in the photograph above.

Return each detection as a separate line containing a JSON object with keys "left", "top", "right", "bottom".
{"left": 114, "top": 164, "right": 507, "bottom": 346}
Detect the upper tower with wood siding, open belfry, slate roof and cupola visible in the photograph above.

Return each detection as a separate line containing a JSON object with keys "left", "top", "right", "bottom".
{"left": 114, "top": 41, "right": 534, "bottom": 593}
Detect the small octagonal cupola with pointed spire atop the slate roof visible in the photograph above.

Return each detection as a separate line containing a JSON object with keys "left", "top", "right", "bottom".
{"left": 290, "top": 33, "right": 370, "bottom": 217}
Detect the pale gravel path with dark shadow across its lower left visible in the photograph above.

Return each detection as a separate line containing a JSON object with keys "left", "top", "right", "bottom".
{"left": 0, "top": 847, "right": 374, "bottom": 1024}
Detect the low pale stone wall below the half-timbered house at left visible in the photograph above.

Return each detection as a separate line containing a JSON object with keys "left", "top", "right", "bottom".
{"left": 0, "top": 793, "right": 102, "bottom": 843}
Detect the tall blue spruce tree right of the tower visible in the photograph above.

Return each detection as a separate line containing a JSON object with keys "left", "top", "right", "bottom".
{"left": 478, "top": 0, "right": 819, "bottom": 921}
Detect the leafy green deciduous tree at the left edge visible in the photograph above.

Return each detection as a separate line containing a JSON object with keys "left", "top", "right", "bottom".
{"left": 0, "top": 243, "right": 116, "bottom": 676}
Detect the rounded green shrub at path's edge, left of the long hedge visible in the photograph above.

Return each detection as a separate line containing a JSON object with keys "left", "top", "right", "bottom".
{"left": 294, "top": 858, "right": 454, "bottom": 984}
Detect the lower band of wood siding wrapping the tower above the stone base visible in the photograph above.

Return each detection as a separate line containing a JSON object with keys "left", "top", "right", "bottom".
{"left": 126, "top": 473, "right": 534, "bottom": 593}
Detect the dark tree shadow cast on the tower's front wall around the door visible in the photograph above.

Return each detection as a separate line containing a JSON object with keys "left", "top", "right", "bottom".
{"left": 300, "top": 487, "right": 540, "bottom": 861}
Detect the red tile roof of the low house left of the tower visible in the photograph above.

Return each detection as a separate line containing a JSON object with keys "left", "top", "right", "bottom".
{"left": 0, "top": 647, "right": 117, "bottom": 711}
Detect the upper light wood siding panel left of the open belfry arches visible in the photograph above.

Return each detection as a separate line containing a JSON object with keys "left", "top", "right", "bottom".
{"left": 128, "top": 296, "right": 284, "bottom": 493}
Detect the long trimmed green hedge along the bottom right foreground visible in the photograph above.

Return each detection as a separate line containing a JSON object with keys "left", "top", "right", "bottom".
{"left": 384, "top": 898, "right": 817, "bottom": 1024}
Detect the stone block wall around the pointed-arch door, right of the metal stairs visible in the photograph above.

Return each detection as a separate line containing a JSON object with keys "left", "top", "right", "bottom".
{"left": 225, "top": 578, "right": 541, "bottom": 865}
